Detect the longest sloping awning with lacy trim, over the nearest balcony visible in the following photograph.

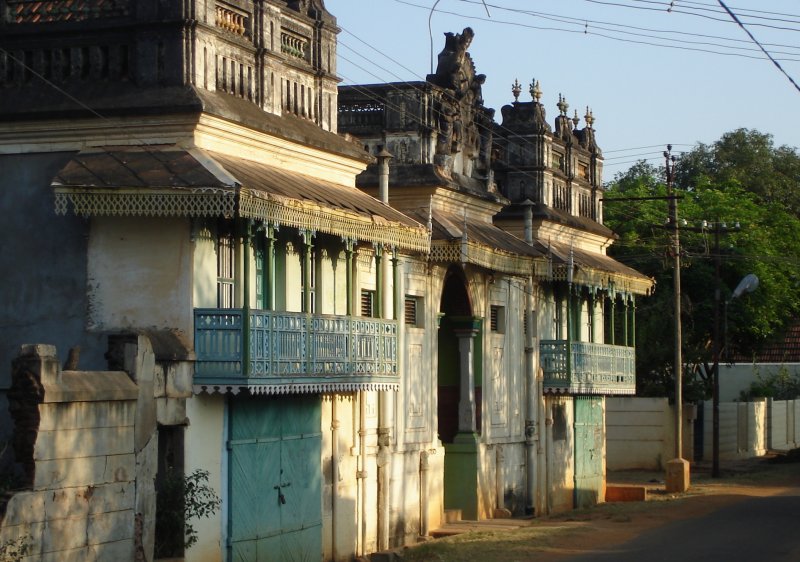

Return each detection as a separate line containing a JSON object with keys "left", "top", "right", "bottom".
{"left": 52, "top": 146, "right": 430, "bottom": 252}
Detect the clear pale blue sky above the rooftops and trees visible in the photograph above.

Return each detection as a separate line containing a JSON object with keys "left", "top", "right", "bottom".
{"left": 325, "top": 0, "right": 800, "bottom": 180}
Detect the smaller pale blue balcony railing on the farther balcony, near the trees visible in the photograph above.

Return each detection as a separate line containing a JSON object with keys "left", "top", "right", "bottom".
{"left": 539, "top": 340, "right": 636, "bottom": 395}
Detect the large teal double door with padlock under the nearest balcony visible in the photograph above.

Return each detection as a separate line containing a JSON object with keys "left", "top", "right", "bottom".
{"left": 228, "top": 395, "right": 322, "bottom": 562}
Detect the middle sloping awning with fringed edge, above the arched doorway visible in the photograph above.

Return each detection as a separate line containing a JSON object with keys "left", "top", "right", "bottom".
{"left": 410, "top": 209, "right": 544, "bottom": 275}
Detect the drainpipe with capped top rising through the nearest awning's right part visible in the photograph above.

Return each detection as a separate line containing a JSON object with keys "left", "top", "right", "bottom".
{"left": 375, "top": 146, "right": 397, "bottom": 550}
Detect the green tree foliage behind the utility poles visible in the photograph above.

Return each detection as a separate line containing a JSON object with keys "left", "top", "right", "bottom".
{"left": 604, "top": 129, "right": 800, "bottom": 399}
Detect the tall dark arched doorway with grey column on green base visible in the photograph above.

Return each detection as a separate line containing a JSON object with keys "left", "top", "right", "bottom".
{"left": 437, "top": 266, "right": 483, "bottom": 519}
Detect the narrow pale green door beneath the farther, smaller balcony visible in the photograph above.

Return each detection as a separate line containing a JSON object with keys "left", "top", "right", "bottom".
{"left": 574, "top": 396, "right": 604, "bottom": 508}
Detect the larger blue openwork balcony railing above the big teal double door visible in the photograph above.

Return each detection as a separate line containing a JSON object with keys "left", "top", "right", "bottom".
{"left": 194, "top": 309, "right": 398, "bottom": 394}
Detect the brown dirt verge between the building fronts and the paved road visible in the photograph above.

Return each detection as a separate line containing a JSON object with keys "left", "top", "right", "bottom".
{"left": 398, "top": 457, "right": 800, "bottom": 562}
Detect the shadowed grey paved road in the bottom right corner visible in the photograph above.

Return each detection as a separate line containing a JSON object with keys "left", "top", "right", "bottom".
{"left": 567, "top": 488, "right": 800, "bottom": 562}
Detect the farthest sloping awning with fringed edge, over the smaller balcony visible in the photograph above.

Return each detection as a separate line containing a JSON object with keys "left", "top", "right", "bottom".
{"left": 536, "top": 242, "right": 655, "bottom": 295}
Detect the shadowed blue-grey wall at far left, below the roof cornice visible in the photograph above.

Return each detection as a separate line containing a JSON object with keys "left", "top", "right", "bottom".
{"left": 0, "top": 150, "right": 105, "bottom": 388}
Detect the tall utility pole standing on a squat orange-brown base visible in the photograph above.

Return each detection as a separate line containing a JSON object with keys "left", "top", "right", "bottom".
{"left": 664, "top": 144, "right": 689, "bottom": 492}
